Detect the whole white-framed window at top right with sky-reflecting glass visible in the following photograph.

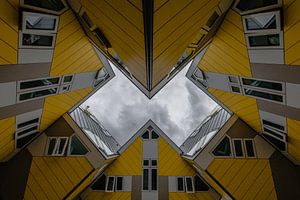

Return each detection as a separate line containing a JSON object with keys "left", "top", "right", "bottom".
{"left": 243, "top": 11, "right": 281, "bottom": 33}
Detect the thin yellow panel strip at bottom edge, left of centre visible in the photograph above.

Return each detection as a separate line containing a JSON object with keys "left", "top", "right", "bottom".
{"left": 83, "top": 191, "right": 131, "bottom": 200}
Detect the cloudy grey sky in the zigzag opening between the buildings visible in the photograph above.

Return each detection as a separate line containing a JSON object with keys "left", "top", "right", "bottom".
{"left": 82, "top": 63, "right": 217, "bottom": 146}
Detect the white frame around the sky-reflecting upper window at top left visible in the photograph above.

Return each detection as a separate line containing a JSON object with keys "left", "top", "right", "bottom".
{"left": 22, "top": 11, "right": 59, "bottom": 34}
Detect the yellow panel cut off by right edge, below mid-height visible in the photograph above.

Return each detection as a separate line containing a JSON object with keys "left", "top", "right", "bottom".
{"left": 287, "top": 118, "right": 300, "bottom": 161}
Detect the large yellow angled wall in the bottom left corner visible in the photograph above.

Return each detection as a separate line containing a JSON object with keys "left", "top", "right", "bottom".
{"left": 24, "top": 157, "right": 93, "bottom": 200}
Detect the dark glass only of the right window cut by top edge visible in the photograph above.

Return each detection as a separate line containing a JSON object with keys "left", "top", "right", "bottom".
{"left": 236, "top": 0, "right": 278, "bottom": 11}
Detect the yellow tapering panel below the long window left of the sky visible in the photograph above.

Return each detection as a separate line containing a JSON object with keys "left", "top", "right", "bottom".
{"left": 40, "top": 87, "right": 92, "bottom": 131}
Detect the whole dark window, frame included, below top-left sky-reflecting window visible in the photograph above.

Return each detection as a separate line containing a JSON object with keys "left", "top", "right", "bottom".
{"left": 20, "top": 32, "right": 55, "bottom": 48}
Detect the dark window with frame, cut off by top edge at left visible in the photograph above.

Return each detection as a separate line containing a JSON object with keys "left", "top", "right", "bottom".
{"left": 21, "top": 0, "right": 67, "bottom": 14}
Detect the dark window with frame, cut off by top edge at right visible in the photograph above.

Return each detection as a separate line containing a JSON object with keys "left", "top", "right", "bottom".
{"left": 235, "top": 0, "right": 281, "bottom": 14}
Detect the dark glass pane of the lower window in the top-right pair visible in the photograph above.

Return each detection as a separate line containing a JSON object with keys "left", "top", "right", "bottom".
{"left": 249, "top": 34, "right": 280, "bottom": 47}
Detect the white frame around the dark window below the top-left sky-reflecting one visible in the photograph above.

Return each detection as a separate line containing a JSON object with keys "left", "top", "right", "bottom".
{"left": 19, "top": 31, "right": 56, "bottom": 49}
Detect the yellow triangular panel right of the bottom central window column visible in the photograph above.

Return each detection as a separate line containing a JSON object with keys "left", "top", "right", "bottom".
{"left": 158, "top": 137, "right": 196, "bottom": 176}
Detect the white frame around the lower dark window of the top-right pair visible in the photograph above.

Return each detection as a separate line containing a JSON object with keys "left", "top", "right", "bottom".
{"left": 245, "top": 31, "right": 284, "bottom": 50}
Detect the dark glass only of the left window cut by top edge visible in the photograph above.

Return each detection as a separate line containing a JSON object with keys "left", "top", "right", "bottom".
{"left": 24, "top": 0, "right": 65, "bottom": 11}
